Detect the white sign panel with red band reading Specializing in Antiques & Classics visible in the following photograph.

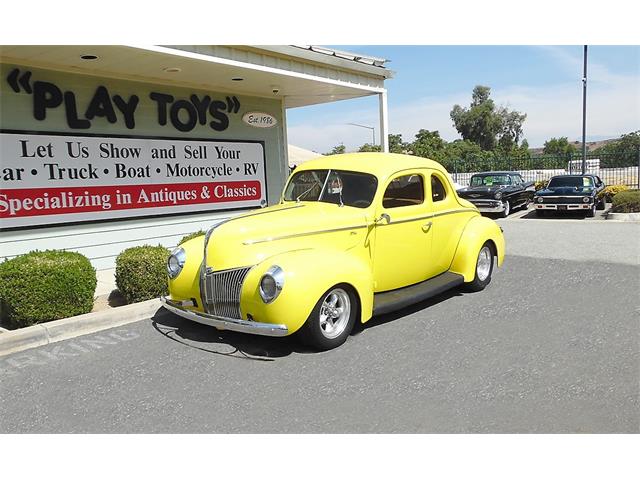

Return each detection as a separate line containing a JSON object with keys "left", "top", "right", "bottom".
{"left": 0, "top": 131, "right": 267, "bottom": 228}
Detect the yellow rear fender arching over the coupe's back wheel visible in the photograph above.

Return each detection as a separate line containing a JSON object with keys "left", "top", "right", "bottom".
{"left": 449, "top": 216, "right": 505, "bottom": 282}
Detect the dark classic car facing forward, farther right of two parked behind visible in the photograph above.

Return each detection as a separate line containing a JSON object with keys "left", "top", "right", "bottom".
{"left": 533, "top": 174, "right": 605, "bottom": 217}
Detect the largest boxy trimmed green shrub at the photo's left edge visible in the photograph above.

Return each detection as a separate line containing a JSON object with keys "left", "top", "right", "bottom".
{"left": 0, "top": 250, "right": 98, "bottom": 328}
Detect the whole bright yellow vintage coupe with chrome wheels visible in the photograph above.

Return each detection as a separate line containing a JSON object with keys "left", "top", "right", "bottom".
{"left": 162, "top": 153, "right": 504, "bottom": 350}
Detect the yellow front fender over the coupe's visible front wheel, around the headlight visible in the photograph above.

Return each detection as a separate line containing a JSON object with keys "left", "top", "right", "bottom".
{"left": 240, "top": 249, "right": 373, "bottom": 333}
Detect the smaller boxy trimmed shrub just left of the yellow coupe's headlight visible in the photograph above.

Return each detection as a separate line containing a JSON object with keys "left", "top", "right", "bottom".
{"left": 116, "top": 245, "right": 169, "bottom": 303}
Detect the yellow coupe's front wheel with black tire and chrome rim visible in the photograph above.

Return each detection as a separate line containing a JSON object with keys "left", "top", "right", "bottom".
{"left": 300, "top": 285, "right": 359, "bottom": 350}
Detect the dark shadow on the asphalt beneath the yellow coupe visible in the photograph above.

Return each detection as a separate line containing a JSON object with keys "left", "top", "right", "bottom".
{"left": 151, "top": 289, "right": 463, "bottom": 362}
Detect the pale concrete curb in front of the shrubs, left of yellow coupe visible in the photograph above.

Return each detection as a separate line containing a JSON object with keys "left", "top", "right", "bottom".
{"left": 0, "top": 298, "right": 161, "bottom": 357}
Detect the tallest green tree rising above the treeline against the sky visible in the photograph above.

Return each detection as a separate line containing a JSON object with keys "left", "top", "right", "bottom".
{"left": 450, "top": 85, "right": 527, "bottom": 151}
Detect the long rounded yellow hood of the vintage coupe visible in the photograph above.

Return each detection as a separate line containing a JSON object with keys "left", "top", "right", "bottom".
{"left": 207, "top": 202, "right": 367, "bottom": 270}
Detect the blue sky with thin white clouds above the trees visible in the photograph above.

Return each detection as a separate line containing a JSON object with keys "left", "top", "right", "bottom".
{"left": 287, "top": 45, "right": 640, "bottom": 152}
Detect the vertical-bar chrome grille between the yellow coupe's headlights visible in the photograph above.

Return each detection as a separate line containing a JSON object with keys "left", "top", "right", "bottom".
{"left": 205, "top": 267, "right": 251, "bottom": 319}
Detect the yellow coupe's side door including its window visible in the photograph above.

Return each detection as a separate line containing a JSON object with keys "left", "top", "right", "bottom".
{"left": 373, "top": 170, "right": 433, "bottom": 292}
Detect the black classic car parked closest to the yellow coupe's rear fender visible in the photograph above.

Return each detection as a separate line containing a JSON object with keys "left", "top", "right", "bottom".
{"left": 458, "top": 172, "right": 534, "bottom": 217}
